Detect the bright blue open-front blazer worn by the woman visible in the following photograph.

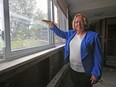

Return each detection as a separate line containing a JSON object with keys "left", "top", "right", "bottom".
{"left": 51, "top": 25, "right": 103, "bottom": 79}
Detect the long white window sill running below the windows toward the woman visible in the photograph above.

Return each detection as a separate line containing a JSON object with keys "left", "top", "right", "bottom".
{"left": 0, "top": 44, "right": 64, "bottom": 75}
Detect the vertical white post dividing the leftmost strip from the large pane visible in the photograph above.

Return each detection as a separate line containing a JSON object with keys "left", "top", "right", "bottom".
{"left": 3, "top": 0, "right": 11, "bottom": 58}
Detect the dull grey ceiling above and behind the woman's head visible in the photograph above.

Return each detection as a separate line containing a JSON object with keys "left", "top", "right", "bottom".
{"left": 65, "top": 0, "right": 116, "bottom": 21}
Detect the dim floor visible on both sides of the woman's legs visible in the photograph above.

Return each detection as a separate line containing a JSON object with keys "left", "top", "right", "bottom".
{"left": 59, "top": 67, "right": 116, "bottom": 87}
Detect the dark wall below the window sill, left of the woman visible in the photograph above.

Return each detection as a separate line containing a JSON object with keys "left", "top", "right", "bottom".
{"left": 0, "top": 48, "right": 64, "bottom": 87}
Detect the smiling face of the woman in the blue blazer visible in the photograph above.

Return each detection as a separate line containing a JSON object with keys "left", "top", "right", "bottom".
{"left": 74, "top": 16, "right": 85, "bottom": 31}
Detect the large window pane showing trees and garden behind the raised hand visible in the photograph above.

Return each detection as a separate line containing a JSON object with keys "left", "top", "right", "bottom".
{"left": 9, "top": 0, "right": 49, "bottom": 50}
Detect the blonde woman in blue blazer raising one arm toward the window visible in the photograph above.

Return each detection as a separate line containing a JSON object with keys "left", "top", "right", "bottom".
{"left": 43, "top": 14, "right": 102, "bottom": 87}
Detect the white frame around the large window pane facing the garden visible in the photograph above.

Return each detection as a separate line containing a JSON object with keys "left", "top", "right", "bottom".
{"left": 0, "top": 0, "right": 68, "bottom": 62}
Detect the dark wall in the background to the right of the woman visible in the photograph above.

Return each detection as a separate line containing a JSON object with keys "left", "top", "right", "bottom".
{"left": 95, "top": 17, "right": 116, "bottom": 67}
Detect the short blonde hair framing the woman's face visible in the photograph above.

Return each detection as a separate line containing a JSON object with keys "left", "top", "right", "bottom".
{"left": 72, "top": 14, "right": 89, "bottom": 30}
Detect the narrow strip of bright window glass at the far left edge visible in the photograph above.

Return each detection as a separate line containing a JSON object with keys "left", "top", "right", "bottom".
{"left": 0, "top": 0, "right": 4, "bottom": 53}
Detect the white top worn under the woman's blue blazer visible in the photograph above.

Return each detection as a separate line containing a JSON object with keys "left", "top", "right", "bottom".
{"left": 69, "top": 34, "right": 85, "bottom": 72}
